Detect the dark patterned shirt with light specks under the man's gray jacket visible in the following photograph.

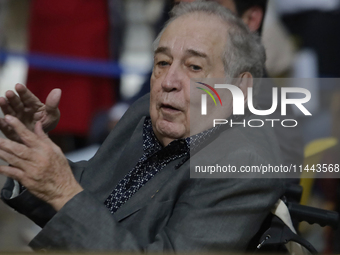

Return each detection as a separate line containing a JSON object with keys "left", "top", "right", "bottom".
{"left": 104, "top": 117, "right": 221, "bottom": 214}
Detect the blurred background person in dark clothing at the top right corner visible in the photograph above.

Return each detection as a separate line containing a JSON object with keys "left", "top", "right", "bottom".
{"left": 276, "top": 0, "right": 340, "bottom": 143}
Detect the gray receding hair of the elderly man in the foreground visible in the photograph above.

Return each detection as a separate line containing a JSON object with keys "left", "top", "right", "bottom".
{"left": 153, "top": 0, "right": 266, "bottom": 78}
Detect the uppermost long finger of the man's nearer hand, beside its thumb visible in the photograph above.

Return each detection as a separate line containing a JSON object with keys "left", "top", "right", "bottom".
{"left": 5, "top": 115, "right": 37, "bottom": 147}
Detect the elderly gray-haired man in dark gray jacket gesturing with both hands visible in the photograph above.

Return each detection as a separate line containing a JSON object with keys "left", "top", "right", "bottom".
{"left": 0, "top": 2, "right": 282, "bottom": 252}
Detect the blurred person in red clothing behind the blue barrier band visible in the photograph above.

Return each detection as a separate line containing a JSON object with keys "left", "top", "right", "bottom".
{"left": 22, "top": 0, "right": 117, "bottom": 152}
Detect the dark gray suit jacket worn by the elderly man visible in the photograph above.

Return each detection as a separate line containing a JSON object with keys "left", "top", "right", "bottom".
{"left": 2, "top": 95, "right": 283, "bottom": 251}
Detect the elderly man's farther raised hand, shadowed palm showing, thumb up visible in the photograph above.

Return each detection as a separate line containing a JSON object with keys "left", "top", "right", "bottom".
{"left": 0, "top": 83, "right": 61, "bottom": 142}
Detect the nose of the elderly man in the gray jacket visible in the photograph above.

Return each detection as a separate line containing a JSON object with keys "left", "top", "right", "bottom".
{"left": 162, "top": 63, "right": 185, "bottom": 92}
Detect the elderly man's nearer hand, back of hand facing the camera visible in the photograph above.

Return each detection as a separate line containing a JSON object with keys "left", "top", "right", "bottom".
{"left": 0, "top": 115, "right": 83, "bottom": 211}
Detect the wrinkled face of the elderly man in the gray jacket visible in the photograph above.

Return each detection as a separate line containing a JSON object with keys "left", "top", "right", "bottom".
{"left": 150, "top": 13, "right": 227, "bottom": 146}
